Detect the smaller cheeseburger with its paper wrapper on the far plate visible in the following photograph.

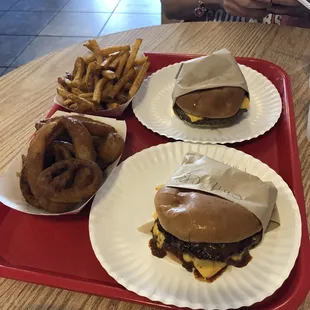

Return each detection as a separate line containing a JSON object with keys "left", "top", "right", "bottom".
{"left": 172, "top": 49, "right": 250, "bottom": 128}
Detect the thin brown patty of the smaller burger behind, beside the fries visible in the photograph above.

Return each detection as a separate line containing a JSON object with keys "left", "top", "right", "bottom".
{"left": 173, "top": 104, "right": 247, "bottom": 128}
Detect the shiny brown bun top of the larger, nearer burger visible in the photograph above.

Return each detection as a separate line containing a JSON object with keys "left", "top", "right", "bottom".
{"left": 154, "top": 187, "right": 262, "bottom": 243}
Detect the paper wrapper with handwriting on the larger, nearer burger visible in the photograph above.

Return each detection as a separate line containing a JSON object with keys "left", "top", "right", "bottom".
{"left": 166, "top": 153, "right": 280, "bottom": 232}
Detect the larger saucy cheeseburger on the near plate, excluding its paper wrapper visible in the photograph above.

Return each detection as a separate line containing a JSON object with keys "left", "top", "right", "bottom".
{"left": 150, "top": 187, "right": 263, "bottom": 282}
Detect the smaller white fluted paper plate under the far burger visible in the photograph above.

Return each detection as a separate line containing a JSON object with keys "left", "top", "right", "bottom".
{"left": 133, "top": 63, "right": 282, "bottom": 144}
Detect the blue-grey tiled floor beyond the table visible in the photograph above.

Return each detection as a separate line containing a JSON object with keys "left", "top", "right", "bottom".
{"left": 0, "top": 0, "right": 161, "bottom": 76}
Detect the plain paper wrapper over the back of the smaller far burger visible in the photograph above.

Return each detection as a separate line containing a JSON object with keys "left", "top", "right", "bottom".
{"left": 172, "top": 49, "right": 249, "bottom": 104}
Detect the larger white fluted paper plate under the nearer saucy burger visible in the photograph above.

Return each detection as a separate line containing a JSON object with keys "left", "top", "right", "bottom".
{"left": 89, "top": 142, "right": 301, "bottom": 309}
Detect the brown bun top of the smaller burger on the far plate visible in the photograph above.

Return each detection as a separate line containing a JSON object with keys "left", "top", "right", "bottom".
{"left": 175, "top": 87, "right": 246, "bottom": 118}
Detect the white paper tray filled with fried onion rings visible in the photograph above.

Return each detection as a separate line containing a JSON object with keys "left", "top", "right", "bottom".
{"left": 0, "top": 111, "right": 126, "bottom": 216}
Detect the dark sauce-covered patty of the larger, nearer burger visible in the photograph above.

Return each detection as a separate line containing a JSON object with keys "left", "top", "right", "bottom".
{"left": 153, "top": 219, "right": 262, "bottom": 264}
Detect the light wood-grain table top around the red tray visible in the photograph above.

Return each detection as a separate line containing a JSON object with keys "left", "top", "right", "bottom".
{"left": 0, "top": 22, "right": 310, "bottom": 310}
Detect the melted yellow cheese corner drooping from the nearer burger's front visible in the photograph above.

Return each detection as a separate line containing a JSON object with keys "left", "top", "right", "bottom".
{"left": 183, "top": 254, "right": 226, "bottom": 279}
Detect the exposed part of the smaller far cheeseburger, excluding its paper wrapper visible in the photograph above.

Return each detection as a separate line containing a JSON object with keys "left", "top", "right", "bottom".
{"left": 173, "top": 86, "right": 250, "bottom": 128}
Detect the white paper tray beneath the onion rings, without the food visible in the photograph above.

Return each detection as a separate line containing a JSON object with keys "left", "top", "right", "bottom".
{"left": 0, "top": 111, "right": 127, "bottom": 216}
